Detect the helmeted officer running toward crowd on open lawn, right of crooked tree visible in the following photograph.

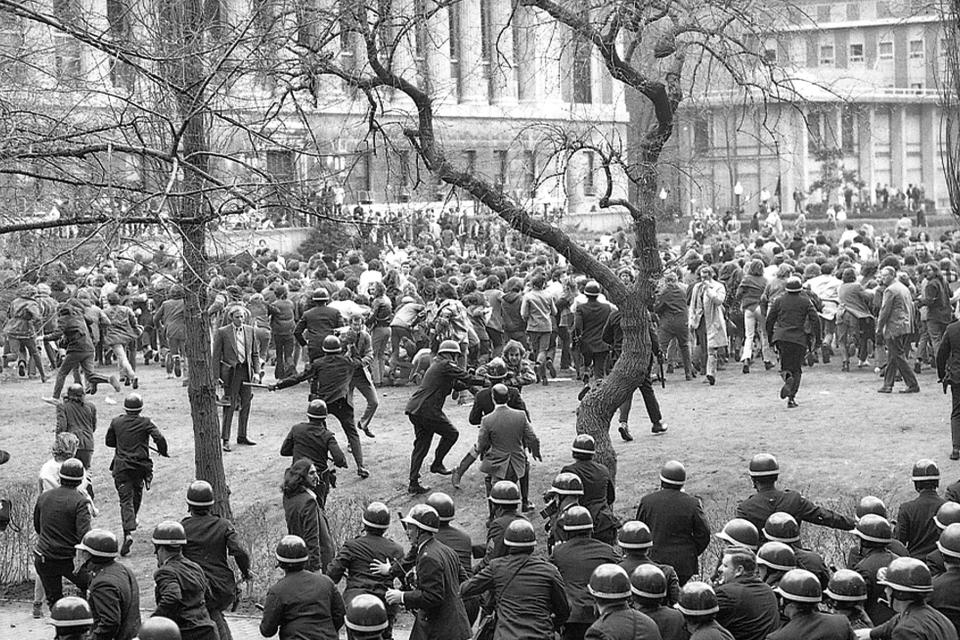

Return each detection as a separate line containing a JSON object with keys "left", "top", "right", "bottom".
{"left": 766, "top": 278, "right": 821, "bottom": 408}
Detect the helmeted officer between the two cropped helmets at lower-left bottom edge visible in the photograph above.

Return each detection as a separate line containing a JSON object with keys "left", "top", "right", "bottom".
{"left": 75, "top": 529, "right": 140, "bottom": 640}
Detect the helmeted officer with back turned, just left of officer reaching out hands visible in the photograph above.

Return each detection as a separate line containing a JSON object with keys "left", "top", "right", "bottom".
{"left": 327, "top": 502, "right": 403, "bottom": 637}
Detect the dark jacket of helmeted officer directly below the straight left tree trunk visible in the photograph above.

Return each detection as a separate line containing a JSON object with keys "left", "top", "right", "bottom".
{"left": 180, "top": 513, "right": 250, "bottom": 611}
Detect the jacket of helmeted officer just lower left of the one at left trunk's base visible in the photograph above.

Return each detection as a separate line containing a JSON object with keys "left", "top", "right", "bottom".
{"left": 153, "top": 555, "right": 216, "bottom": 631}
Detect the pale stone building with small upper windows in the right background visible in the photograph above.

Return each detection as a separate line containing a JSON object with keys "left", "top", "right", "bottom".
{"left": 668, "top": 0, "right": 947, "bottom": 214}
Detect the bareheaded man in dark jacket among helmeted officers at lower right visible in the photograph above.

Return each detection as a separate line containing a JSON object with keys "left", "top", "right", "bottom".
{"left": 716, "top": 547, "right": 780, "bottom": 640}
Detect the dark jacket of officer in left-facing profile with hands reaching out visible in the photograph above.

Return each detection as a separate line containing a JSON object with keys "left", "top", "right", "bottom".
{"left": 403, "top": 538, "right": 472, "bottom": 640}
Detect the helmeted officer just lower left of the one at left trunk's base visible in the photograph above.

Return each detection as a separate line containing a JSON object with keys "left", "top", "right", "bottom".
{"left": 152, "top": 520, "right": 220, "bottom": 640}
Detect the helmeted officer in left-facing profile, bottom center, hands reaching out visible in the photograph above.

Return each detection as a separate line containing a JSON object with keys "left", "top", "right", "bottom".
{"left": 380, "top": 504, "right": 472, "bottom": 640}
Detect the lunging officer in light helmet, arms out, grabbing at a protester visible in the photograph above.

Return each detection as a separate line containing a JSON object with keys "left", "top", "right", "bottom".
{"left": 404, "top": 340, "right": 484, "bottom": 495}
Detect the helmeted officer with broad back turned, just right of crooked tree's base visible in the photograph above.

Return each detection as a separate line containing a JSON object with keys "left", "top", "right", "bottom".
{"left": 637, "top": 460, "right": 710, "bottom": 587}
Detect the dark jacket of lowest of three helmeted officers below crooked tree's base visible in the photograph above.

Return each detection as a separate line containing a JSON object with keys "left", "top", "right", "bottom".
{"left": 550, "top": 536, "right": 620, "bottom": 622}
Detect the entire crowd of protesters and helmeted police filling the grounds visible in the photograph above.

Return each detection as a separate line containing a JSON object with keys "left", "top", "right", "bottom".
{"left": 9, "top": 201, "right": 960, "bottom": 640}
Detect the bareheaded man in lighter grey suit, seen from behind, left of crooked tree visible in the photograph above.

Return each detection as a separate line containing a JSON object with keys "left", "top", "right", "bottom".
{"left": 477, "top": 384, "right": 542, "bottom": 496}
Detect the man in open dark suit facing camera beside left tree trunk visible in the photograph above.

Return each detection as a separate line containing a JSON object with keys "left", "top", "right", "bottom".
{"left": 212, "top": 307, "right": 260, "bottom": 451}
